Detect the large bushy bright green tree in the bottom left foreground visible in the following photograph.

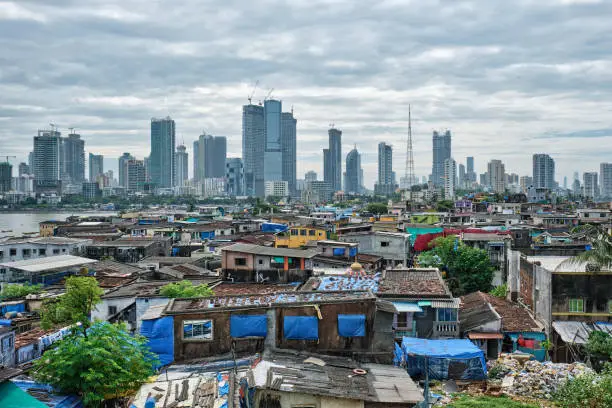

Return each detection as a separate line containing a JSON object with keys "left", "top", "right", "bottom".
{"left": 33, "top": 322, "right": 157, "bottom": 407}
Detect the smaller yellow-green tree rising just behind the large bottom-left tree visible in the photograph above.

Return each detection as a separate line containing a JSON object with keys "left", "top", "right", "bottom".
{"left": 41, "top": 276, "right": 104, "bottom": 336}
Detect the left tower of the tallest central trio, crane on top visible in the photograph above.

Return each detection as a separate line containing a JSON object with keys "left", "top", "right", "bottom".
{"left": 241, "top": 104, "right": 265, "bottom": 197}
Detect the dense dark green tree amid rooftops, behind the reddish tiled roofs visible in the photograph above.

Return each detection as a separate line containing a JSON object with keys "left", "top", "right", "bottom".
{"left": 418, "top": 236, "right": 493, "bottom": 296}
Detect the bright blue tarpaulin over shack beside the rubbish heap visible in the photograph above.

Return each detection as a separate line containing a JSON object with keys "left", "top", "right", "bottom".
{"left": 402, "top": 337, "right": 487, "bottom": 380}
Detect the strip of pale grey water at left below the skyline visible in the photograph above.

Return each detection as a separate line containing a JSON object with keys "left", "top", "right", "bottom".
{"left": 0, "top": 211, "right": 117, "bottom": 237}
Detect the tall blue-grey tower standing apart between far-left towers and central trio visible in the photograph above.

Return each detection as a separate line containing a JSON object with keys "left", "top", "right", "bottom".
{"left": 149, "top": 116, "right": 176, "bottom": 188}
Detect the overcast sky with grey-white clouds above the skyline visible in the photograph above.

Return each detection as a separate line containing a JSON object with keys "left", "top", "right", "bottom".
{"left": 0, "top": 0, "right": 612, "bottom": 188}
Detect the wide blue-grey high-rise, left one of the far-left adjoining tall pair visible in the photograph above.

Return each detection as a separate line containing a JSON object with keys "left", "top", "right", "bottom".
{"left": 33, "top": 130, "right": 62, "bottom": 186}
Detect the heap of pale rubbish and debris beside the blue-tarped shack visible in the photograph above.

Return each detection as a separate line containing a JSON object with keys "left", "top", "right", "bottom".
{"left": 490, "top": 354, "right": 593, "bottom": 399}
